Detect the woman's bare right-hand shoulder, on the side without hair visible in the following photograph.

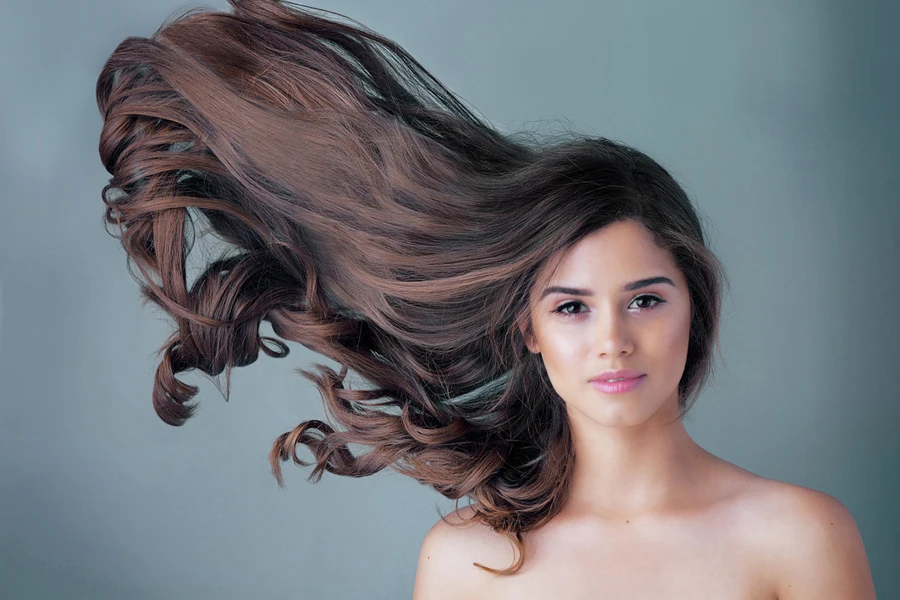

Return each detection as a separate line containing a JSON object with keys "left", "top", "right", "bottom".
{"left": 748, "top": 478, "right": 875, "bottom": 600}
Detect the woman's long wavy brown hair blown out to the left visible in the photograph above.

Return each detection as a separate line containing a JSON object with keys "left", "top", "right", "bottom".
{"left": 96, "top": 0, "right": 727, "bottom": 574}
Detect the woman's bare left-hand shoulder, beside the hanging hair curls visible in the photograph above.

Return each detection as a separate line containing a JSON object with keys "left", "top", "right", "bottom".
{"left": 413, "top": 506, "right": 515, "bottom": 600}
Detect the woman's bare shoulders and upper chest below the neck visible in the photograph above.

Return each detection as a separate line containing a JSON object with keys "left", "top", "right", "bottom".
{"left": 413, "top": 458, "right": 876, "bottom": 600}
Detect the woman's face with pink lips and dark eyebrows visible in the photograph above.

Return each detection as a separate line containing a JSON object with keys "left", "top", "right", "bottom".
{"left": 526, "top": 220, "right": 691, "bottom": 426}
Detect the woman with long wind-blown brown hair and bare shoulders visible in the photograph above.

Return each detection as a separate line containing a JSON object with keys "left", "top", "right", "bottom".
{"left": 97, "top": 0, "right": 874, "bottom": 600}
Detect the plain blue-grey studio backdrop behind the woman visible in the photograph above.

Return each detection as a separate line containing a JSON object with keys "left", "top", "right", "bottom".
{"left": 0, "top": 0, "right": 900, "bottom": 600}
